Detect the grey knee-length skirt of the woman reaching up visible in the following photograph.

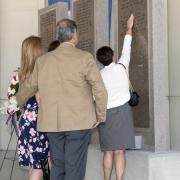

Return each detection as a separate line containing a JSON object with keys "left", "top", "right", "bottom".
{"left": 98, "top": 103, "right": 135, "bottom": 151}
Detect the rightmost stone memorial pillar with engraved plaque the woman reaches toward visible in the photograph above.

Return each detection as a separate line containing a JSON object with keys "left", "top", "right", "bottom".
{"left": 112, "top": 0, "right": 170, "bottom": 151}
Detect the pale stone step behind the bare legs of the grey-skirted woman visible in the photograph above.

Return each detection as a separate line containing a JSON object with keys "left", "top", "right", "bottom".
{"left": 85, "top": 145, "right": 151, "bottom": 180}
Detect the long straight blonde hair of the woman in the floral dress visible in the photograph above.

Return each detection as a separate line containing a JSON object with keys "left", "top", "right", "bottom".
{"left": 19, "top": 36, "right": 43, "bottom": 83}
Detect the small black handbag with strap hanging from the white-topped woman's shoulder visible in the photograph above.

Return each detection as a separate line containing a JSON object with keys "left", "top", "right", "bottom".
{"left": 118, "top": 63, "right": 140, "bottom": 106}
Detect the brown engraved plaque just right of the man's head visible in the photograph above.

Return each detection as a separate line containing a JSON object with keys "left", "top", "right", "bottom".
{"left": 73, "top": 0, "right": 95, "bottom": 55}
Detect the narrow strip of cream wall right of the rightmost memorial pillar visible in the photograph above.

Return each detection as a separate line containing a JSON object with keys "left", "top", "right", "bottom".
{"left": 168, "top": 0, "right": 180, "bottom": 150}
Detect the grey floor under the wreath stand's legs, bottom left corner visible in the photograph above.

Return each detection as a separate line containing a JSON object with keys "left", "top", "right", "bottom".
{"left": 0, "top": 151, "right": 28, "bottom": 180}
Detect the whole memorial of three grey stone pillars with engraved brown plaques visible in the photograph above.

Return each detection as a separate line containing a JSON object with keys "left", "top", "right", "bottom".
{"left": 39, "top": 0, "right": 169, "bottom": 150}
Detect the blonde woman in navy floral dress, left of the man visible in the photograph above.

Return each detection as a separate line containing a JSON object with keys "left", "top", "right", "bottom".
{"left": 18, "top": 36, "right": 49, "bottom": 180}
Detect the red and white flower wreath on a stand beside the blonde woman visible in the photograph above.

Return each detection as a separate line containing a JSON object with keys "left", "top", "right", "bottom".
{"left": 0, "top": 74, "right": 21, "bottom": 135}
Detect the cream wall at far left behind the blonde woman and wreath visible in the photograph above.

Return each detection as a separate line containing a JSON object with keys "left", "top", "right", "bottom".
{"left": 0, "top": 0, "right": 45, "bottom": 149}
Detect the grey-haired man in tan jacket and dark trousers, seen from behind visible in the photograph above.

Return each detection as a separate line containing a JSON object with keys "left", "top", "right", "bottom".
{"left": 17, "top": 19, "right": 107, "bottom": 180}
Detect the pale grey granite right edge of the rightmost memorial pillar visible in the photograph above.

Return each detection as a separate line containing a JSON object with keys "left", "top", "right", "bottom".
{"left": 149, "top": 0, "right": 170, "bottom": 151}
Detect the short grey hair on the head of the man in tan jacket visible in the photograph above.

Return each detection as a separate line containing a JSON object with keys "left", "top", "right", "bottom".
{"left": 57, "top": 19, "right": 77, "bottom": 43}
